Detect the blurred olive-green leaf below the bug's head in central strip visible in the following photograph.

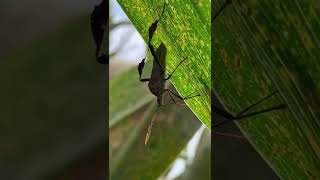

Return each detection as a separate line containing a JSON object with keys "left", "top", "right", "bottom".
{"left": 109, "top": 102, "right": 201, "bottom": 180}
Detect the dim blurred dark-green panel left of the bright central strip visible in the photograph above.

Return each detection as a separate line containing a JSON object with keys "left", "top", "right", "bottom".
{"left": 0, "top": 0, "right": 107, "bottom": 180}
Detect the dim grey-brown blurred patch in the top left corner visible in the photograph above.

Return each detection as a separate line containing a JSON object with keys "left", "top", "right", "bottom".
{"left": 0, "top": 0, "right": 94, "bottom": 57}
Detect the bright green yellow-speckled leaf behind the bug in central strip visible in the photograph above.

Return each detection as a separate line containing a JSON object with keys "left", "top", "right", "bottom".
{"left": 118, "top": 0, "right": 211, "bottom": 129}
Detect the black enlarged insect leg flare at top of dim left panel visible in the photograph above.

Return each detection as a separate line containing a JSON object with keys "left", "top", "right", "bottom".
{"left": 91, "top": 0, "right": 109, "bottom": 64}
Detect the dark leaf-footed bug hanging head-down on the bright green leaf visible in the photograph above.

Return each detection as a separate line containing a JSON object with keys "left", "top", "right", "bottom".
{"left": 138, "top": 3, "right": 200, "bottom": 145}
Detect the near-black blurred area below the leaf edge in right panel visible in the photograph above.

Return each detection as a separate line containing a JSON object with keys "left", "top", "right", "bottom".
{"left": 211, "top": 123, "right": 279, "bottom": 180}
